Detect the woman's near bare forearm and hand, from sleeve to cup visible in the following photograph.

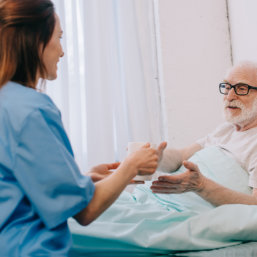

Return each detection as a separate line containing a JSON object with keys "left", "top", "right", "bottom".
{"left": 74, "top": 143, "right": 158, "bottom": 226}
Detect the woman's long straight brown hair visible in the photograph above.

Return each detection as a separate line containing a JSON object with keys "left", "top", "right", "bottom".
{"left": 0, "top": 0, "right": 55, "bottom": 88}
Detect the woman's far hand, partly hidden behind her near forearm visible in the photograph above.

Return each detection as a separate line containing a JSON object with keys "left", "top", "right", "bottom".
{"left": 85, "top": 162, "right": 120, "bottom": 183}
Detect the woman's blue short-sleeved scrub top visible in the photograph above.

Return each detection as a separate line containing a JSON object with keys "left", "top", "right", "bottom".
{"left": 0, "top": 82, "right": 95, "bottom": 256}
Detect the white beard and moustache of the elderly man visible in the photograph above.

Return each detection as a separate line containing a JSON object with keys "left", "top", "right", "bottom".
{"left": 224, "top": 98, "right": 257, "bottom": 126}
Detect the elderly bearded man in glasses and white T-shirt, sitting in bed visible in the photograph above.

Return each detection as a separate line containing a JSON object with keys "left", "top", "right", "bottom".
{"left": 151, "top": 62, "right": 257, "bottom": 206}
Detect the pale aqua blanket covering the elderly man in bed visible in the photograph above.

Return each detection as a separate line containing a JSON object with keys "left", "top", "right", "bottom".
{"left": 69, "top": 147, "right": 254, "bottom": 253}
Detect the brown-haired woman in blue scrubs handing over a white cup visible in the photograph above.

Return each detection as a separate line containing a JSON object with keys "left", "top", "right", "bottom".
{"left": 0, "top": 0, "right": 166, "bottom": 256}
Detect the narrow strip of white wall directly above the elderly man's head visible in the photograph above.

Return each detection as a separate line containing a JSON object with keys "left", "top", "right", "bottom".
{"left": 228, "top": 0, "right": 257, "bottom": 63}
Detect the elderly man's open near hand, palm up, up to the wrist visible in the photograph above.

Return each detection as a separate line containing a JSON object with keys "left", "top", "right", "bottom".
{"left": 151, "top": 161, "right": 205, "bottom": 194}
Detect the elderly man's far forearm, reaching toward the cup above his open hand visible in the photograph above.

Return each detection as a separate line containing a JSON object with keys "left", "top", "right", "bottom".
{"left": 158, "top": 143, "right": 202, "bottom": 172}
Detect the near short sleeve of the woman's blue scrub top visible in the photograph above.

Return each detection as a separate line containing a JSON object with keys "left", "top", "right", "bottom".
{"left": 13, "top": 105, "right": 94, "bottom": 229}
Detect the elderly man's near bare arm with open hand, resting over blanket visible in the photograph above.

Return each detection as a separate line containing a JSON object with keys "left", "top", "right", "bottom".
{"left": 151, "top": 161, "right": 257, "bottom": 206}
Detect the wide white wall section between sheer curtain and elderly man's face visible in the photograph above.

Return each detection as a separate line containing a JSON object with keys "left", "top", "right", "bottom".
{"left": 158, "top": 0, "right": 231, "bottom": 147}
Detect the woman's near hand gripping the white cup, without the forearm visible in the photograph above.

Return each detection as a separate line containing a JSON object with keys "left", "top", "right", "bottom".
{"left": 122, "top": 143, "right": 159, "bottom": 175}
